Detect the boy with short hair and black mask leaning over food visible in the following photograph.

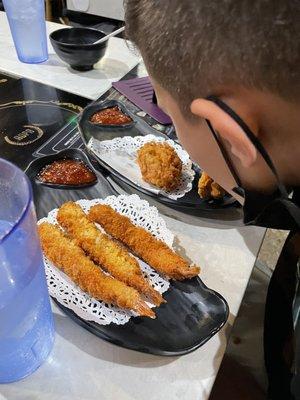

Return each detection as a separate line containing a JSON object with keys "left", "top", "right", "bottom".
{"left": 125, "top": 0, "right": 300, "bottom": 400}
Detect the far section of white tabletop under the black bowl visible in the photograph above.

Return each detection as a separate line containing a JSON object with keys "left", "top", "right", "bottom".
{"left": 0, "top": 12, "right": 140, "bottom": 99}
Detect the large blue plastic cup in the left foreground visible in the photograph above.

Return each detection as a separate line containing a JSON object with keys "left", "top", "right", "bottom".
{"left": 0, "top": 159, "right": 54, "bottom": 383}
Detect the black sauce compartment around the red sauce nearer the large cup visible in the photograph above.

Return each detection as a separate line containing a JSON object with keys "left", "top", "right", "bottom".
{"left": 25, "top": 148, "right": 98, "bottom": 190}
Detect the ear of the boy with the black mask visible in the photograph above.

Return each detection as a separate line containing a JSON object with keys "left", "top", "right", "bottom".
{"left": 191, "top": 99, "right": 257, "bottom": 168}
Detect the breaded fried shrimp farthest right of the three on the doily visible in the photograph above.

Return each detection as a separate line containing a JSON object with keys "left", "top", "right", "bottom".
{"left": 89, "top": 204, "right": 200, "bottom": 280}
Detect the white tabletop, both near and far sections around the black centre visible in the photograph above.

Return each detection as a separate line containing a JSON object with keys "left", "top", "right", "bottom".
{"left": 0, "top": 15, "right": 265, "bottom": 400}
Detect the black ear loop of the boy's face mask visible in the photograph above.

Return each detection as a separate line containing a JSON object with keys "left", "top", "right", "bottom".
{"left": 207, "top": 96, "right": 289, "bottom": 198}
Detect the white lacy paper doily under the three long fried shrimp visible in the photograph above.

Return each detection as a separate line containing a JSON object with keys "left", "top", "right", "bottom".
{"left": 38, "top": 194, "right": 174, "bottom": 325}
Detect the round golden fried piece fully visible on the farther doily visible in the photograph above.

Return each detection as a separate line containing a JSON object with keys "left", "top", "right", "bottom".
{"left": 137, "top": 142, "right": 182, "bottom": 190}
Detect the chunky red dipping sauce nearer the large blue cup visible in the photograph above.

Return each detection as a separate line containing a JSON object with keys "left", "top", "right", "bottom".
{"left": 38, "top": 159, "right": 97, "bottom": 186}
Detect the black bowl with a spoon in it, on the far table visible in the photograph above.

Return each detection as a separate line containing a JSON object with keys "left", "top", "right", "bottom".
{"left": 49, "top": 28, "right": 108, "bottom": 71}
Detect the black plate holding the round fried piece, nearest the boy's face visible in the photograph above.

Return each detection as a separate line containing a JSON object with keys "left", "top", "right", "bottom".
{"left": 78, "top": 101, "right": 237, "bottom": 211}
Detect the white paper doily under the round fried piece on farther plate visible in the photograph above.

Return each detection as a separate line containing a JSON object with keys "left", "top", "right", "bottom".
{"left": 88, "top": 135, "right": 195, "bottom": 200}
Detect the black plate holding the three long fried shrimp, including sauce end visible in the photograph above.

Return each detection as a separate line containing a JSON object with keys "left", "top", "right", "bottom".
{"left": 26, "top": 149, "right": 229, "bottom": 356}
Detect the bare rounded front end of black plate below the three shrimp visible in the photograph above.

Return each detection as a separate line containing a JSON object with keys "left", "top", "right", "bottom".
{"left": 56, "top": 278, "right": 229, "bottom": 356}
